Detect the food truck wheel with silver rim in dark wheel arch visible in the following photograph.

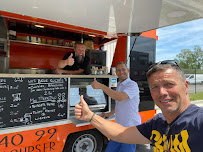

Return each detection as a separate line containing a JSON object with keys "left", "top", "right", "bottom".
{"left": 64, "top": 129, "right": 104, "bottom": 152}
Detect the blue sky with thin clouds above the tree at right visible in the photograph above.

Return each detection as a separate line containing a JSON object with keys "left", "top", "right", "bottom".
{"left": 156, "top": 19, "right": 203, "bottom": 62}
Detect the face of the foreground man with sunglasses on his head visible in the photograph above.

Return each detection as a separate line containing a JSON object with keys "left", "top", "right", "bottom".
{"left": 148, "top": 68, "right": 188, "bottom": 114}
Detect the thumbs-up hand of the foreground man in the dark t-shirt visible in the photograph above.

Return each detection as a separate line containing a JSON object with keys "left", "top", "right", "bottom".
{"left": 75, "top": 95, "right": 93, "bottom": 121}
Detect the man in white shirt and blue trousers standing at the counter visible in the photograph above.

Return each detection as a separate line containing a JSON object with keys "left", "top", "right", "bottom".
{"left": 91, "top": 62, "right": 141, "bottom": 152}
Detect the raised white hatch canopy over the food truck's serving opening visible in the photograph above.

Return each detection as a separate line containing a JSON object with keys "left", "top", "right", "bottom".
{"left": 0, "top": 0, "right": 203, "bottom": 36}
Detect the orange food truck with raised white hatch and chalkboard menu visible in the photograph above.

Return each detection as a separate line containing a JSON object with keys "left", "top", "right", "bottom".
{"left": 0, "top": 0, "right": 203, "bottom": 152}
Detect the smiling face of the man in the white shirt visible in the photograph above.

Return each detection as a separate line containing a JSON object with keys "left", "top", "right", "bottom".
{"left": 116, "top": 64, "right": 129, "bottom": 82}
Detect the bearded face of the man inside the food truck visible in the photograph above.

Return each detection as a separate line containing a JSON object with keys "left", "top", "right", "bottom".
{"left": 75, "top": 44, "right": 85, "bottom": 63}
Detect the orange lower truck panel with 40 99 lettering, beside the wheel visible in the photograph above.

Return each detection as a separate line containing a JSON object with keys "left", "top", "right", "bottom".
{"left": 0, "top": 123, "right": 93, "bottom": 152}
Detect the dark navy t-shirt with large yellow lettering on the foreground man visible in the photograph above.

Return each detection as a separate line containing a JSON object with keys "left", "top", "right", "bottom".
{"left": 137, "top": 104, "right": 203, "bottom": 152}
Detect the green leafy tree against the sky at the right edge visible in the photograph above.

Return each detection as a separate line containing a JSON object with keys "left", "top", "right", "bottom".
{"left": 174, "top": 45, "right": 203, "bottom": 69}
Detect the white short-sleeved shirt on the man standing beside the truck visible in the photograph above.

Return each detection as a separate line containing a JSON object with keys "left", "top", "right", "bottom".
{"left": 115, "top": 78, "right": 141, "bottom": 127}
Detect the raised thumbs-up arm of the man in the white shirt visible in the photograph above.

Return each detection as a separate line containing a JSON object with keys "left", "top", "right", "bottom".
{"left": 91, "top": 78, "right": 128, "bottom": 101}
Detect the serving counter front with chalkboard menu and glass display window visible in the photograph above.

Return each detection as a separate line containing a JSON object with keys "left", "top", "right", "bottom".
{"left": 0, "top": 74, "right": 117, "bottom": 129}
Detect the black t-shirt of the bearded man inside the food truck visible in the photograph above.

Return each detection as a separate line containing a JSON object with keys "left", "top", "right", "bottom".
{"left": 63, "top": 52, "right": 90, "bottom": 74}
